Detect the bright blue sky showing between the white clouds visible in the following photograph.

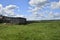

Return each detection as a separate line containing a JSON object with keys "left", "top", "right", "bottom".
{"left": 0, "top": 0, "right": 60, "bottom": 20}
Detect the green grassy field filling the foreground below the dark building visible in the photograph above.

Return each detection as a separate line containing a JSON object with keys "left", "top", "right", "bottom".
{"left": 0, "top": 21, "right": 60, "bottom": 40}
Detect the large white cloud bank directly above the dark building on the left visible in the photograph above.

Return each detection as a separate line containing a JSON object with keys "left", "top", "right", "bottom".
{"left": 0, "top": 4, "right": 23, "bottom": 17}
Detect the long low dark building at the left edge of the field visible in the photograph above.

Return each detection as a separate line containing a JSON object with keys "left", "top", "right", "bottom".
{"left": 0, "top": 15, "right": 26, "bottom": 24}
